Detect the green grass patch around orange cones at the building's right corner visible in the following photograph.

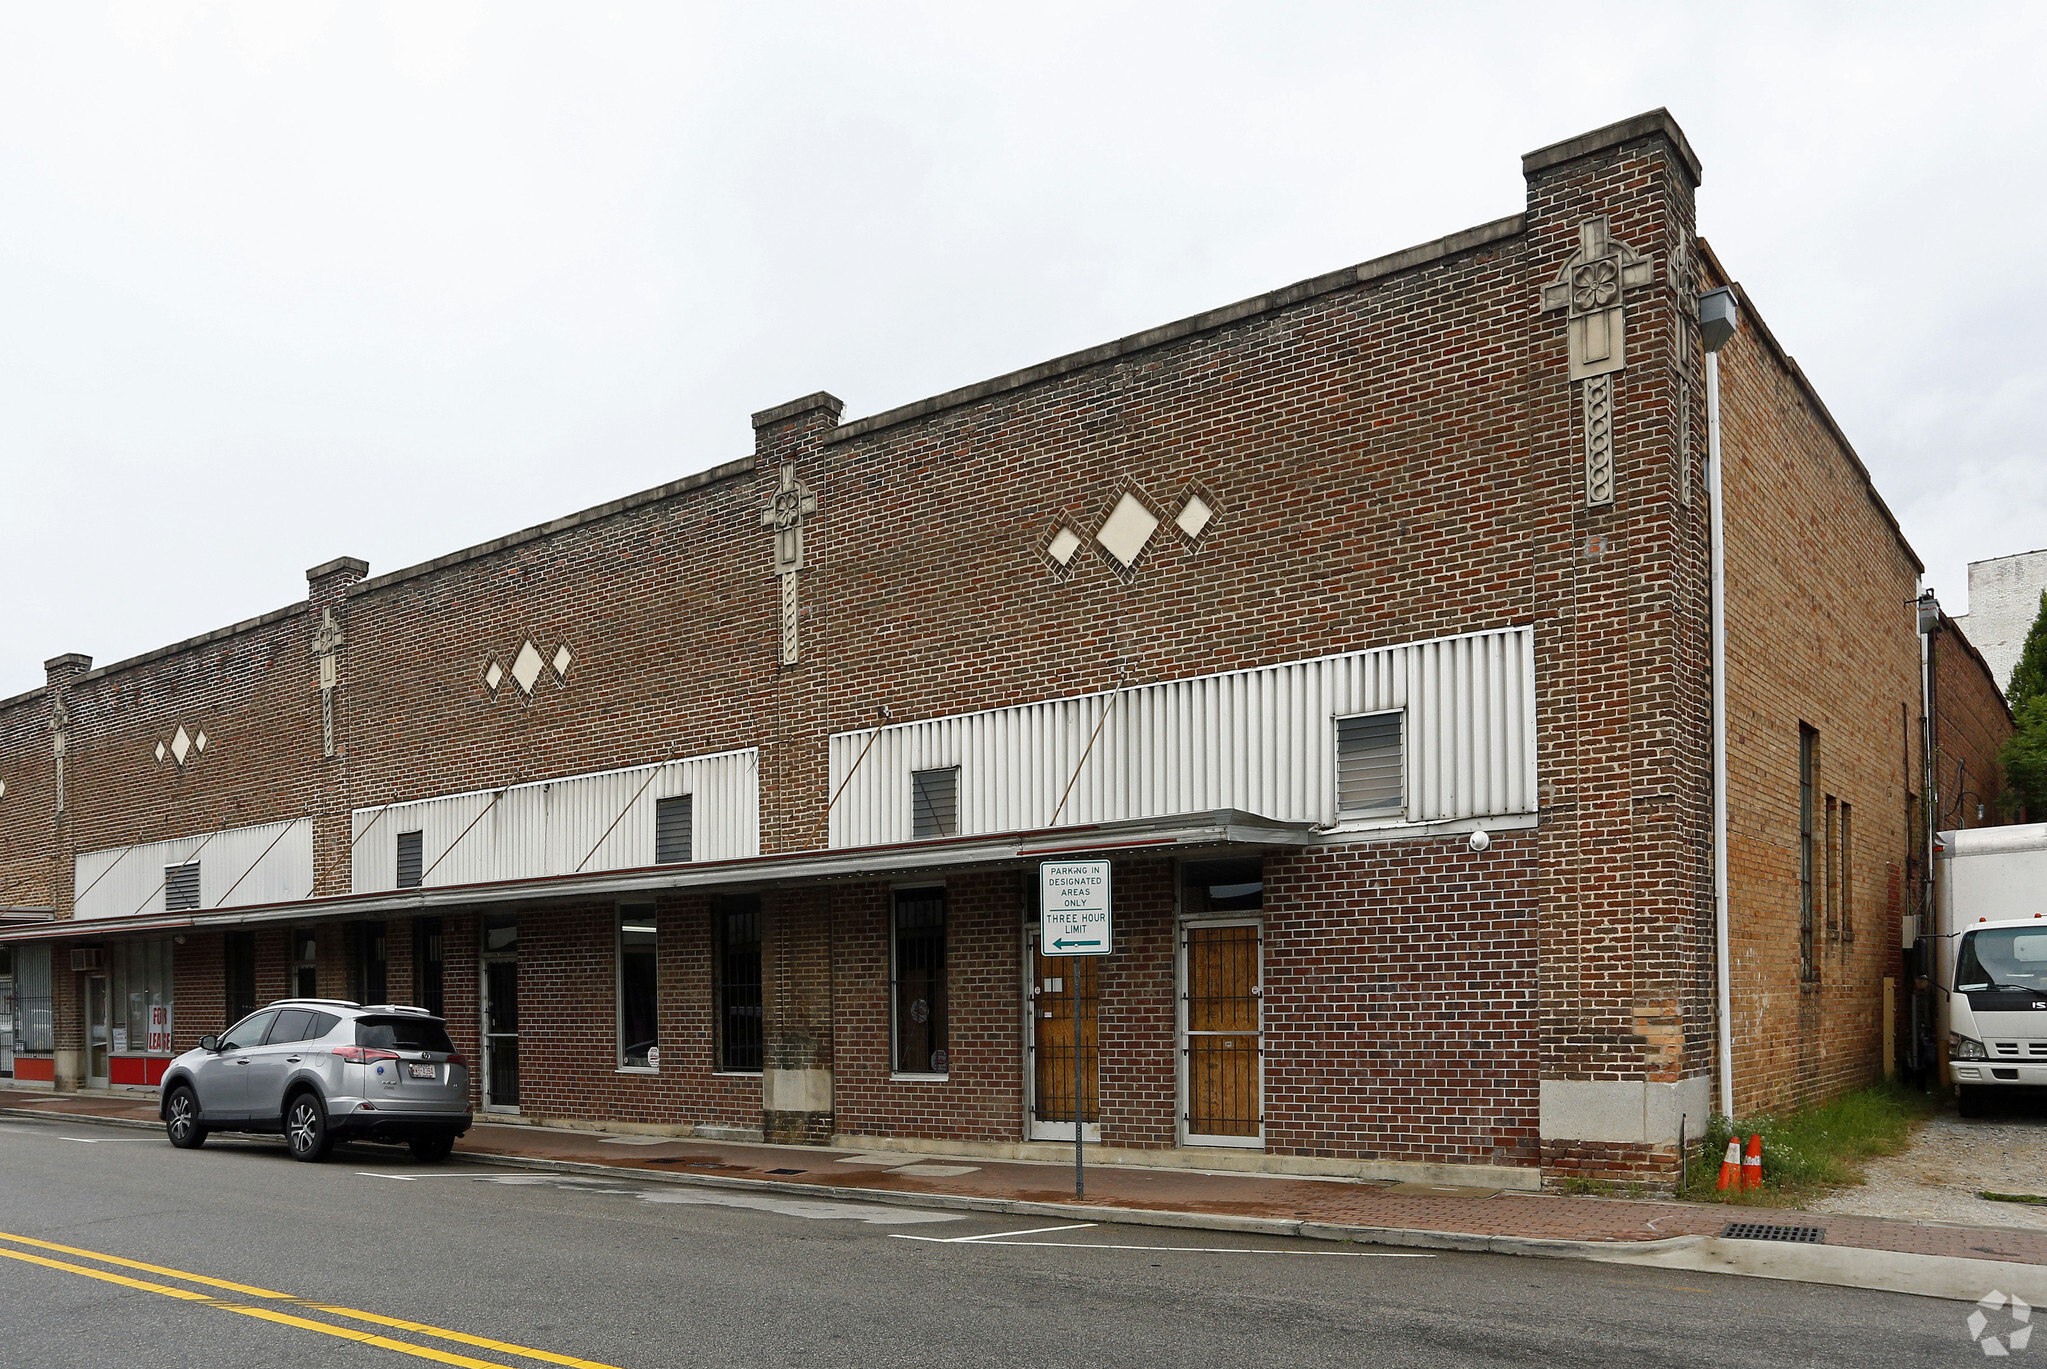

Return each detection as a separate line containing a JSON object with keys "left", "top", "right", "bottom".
{"left": 1683, "top": 1080, "right": 1941, "bottom": 1207}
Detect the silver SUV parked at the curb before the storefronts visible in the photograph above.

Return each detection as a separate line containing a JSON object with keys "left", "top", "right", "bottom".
{"left": 158, "top": 999, "right": 475, "bottom": 1162}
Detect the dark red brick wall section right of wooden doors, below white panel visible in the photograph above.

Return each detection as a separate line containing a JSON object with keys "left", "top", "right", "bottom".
{"left": 1265, "top": 833, "right": 1541, "bottom": 1164}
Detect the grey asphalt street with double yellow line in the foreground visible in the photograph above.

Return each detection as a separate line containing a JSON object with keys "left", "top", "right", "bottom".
{"left": 0, "top": 1119, "right": 1981, "bottom": 1369}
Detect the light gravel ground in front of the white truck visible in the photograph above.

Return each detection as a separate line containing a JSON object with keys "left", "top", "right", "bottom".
{"left": 1810, "top": 1109, "right": 2047, "bottom": 1228}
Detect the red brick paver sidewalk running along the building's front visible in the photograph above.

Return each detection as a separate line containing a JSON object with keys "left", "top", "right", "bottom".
{"left": 15, "top": 1091, "right": 2047, "bottom": 1265}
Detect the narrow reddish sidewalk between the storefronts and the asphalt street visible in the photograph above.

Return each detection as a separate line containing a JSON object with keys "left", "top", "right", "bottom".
{"left": 12, "top": 1091, "right": 2047, "bottom": 1276}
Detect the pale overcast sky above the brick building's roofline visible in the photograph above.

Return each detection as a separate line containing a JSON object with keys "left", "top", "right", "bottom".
{"left": 0, "top": 0, "right": 2047, "bottom": 696}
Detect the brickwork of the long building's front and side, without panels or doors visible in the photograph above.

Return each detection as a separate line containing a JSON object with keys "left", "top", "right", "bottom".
{"left": 0, "top": 112, "right": 1914, "bottom": 1164}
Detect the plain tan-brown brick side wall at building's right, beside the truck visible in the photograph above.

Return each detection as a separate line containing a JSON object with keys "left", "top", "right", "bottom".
{"left": 1719, "top": 274, "right": 1920, "bottom": 1111}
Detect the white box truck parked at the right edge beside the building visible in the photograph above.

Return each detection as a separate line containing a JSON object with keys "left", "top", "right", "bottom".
{"left": 1932, "top": 823, "right": 2047, "bottom": 1117}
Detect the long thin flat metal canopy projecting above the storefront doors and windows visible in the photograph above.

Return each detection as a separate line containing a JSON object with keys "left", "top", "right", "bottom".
{"left": 0, "top": 808, "right": 1324, "bottom": 941}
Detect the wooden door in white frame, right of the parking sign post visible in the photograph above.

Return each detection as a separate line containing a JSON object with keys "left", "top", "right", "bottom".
{"left": 1185, "top": 925, "right": 1263, "bottom": 1140}
